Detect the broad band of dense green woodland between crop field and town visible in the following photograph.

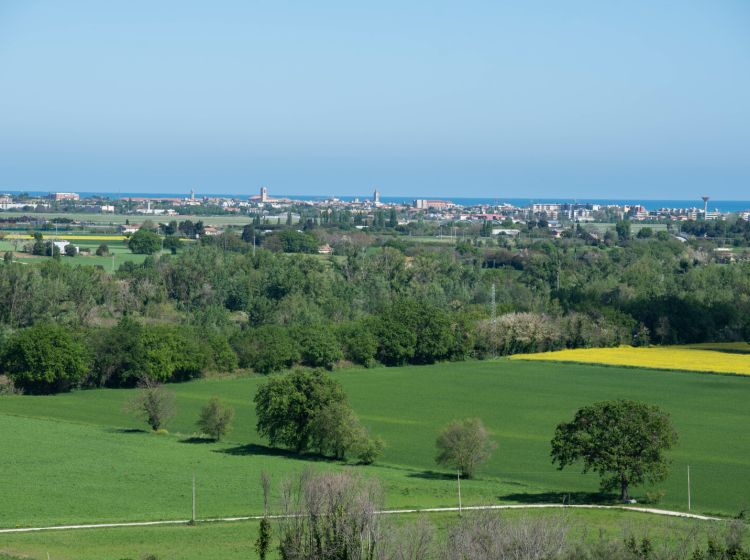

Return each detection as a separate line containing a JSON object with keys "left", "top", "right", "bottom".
{"left": 0, "top": 228, "right": 750, "bottom": 392}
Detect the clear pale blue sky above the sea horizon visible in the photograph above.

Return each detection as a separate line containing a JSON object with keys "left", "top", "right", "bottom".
{"left": 0, "top": 0, "right": 750, "bottom": 199}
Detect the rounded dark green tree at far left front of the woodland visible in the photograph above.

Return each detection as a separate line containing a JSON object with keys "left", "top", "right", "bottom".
{"left": 0, "top": 323, "right": 89, "bottom": 393}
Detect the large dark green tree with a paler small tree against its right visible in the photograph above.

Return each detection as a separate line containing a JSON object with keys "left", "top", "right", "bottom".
{"left": 254, "top": 370, "right": 346, "bottom": 453}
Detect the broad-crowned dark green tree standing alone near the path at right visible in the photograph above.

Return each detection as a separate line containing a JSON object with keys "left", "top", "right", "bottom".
{"left": 552, "top": 400, "right": 677, "bottom": 500}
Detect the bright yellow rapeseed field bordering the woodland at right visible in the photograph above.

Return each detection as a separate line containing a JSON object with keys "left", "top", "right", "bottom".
{"left": 511, "top": 342, "right": 750, "bottom": 375}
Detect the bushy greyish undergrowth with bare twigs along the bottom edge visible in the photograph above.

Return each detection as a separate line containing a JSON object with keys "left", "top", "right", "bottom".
{"left": 274, "top": 471, "right": 750, "bottom": 560}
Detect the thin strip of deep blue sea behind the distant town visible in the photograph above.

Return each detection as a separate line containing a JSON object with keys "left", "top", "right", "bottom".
{"left": 0, "top": 190, "right": 750, "bottom": 212}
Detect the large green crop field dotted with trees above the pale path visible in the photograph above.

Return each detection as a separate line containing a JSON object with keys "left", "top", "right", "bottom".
{"left": 0, "top": 359, "right": 750, "bottom": 557}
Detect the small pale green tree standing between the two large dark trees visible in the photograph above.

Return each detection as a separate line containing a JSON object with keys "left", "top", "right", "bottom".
{"left": 435, "top": 418, "right": 496, "bottom": 478}
